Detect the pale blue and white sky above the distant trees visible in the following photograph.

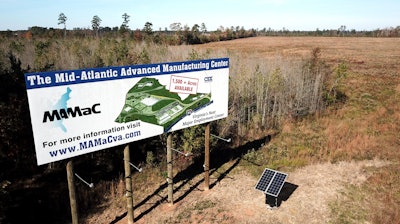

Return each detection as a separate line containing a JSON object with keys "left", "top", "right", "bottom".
{"left": 0, "top": 0, "right": 400, "bottom": 31}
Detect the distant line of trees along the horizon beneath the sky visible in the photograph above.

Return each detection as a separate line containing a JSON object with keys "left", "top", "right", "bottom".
{"left": 0, "top": 13, "right": 400, "bottom": 45}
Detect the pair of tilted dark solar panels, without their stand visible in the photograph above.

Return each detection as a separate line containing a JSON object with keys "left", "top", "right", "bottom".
{"left": 255, "top": 168, "right": 287, "bottom": 197}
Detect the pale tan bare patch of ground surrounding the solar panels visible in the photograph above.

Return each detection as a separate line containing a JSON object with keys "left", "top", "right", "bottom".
{"left": 92, "top": 160, "right": 389, "bottom": 224}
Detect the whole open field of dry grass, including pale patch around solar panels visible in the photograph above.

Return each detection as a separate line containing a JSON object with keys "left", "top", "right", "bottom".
{"left": 79, "top": 37, "right": 400, "bottom": 223}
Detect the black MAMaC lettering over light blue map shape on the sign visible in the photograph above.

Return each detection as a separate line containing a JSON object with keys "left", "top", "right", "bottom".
{"left": 43, "top": 87, "right": 101, "bottom": 132}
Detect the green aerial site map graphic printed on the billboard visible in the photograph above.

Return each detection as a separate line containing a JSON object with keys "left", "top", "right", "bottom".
{"left": 115, "top": 78, "right": 211, "bottom": 131}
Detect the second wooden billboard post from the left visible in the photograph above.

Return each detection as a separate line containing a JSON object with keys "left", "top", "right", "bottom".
{"left": 124, "top": 145, "right": 134, "bottom": 224}
